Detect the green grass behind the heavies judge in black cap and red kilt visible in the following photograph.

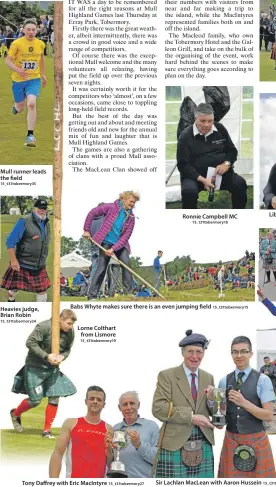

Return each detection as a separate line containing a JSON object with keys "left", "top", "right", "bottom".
{"left": 0, "top": 215, "right": 53, "bottom": 302}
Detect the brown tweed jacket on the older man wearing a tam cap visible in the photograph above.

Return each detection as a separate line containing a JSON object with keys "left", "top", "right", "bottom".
{"left": 152, "top": 364, "right": 214, "bottom": 451}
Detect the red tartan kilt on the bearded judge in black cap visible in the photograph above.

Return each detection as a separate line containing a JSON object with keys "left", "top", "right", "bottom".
{"left": 1, "top": 267, "right": 51, "bottom": 293}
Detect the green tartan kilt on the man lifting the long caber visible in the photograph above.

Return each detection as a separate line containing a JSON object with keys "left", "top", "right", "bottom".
{"left": 24, "top": 365, "right": 77, "bottom": 401}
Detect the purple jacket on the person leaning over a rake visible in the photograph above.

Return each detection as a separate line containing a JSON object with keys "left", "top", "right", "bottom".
{"left": 84, "top": 200, "right": 135, "bottom": 252}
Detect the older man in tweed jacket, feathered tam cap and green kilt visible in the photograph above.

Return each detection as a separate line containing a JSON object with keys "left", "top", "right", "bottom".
{"left": 152, "top": 330, "right": 214, "bottom": 478}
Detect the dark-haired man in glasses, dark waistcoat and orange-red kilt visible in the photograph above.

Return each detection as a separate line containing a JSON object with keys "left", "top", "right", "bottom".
{"left": 218, "top": 336, "right": 276, "bottom": 478}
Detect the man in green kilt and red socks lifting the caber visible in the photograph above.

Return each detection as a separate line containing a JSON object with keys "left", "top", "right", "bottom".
{"left": 10, "top": 309, "right": 77, "bottom": 438}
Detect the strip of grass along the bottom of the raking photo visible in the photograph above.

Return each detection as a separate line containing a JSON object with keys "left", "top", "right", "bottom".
{"left": 60, "top": 287, "right": 255, "bottom": 303}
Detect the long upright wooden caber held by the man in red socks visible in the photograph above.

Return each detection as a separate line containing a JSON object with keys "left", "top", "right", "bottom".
{"left": 52, "top": 1, "right": 63, "bottom": 355}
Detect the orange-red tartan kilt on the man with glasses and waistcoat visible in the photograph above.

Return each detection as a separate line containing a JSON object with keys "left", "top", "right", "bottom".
{"left": 218, "top": 431, "right": 276, "bottom": 479}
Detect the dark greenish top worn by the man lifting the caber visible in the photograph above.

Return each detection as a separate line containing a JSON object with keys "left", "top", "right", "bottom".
{"left": 25, "top": 320, "right": 74, "bottom": 369}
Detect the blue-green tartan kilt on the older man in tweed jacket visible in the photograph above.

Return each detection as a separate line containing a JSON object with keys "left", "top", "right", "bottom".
{"left": 155, "top": 426, "right": 214, "bottom": 479}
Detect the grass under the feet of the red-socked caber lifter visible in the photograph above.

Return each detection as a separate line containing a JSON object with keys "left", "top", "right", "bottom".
{"left": 1, "top": 396, "right": 60, "bottom": 458}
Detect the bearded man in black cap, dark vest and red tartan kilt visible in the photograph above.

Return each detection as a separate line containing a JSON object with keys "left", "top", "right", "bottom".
{"left": 1, "top": 199, "right": 51, "bottom": 302}
